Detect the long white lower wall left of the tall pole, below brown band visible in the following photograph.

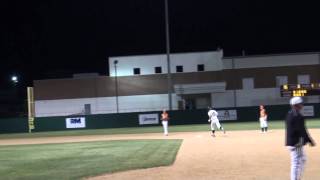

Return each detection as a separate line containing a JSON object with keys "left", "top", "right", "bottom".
{"left": 35, "top": 94, "right": 178, "bottom": 117}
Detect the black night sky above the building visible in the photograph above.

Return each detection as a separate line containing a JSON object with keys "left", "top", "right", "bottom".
{"left": 0, "top": 0, "right": 320, "bottom": 88}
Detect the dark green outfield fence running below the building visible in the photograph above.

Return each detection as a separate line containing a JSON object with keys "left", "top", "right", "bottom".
{"left": 0, "top": 104, "right": 320, "bottom": 133}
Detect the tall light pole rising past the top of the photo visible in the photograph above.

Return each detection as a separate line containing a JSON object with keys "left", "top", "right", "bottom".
{"left": 164, "top": 0, "right": 172, "bottom": 110}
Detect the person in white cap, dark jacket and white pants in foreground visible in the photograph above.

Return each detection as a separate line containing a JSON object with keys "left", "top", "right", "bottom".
{"left": 286, "top": 97, "right": 315, "bottom": 180}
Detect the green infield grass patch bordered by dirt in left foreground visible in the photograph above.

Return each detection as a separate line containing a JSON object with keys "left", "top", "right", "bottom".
{"left": 0, "top": 140, "right": 182, "bottom": 180}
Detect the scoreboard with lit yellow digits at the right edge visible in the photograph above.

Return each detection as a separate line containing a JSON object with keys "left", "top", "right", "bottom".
{"left": 280, "top": 83, "right": 320, "bottom": 97}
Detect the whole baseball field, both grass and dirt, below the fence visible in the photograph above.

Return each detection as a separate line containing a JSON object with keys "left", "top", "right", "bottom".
{"left": 0, "top": 119, "right": 320, "bottom": 180}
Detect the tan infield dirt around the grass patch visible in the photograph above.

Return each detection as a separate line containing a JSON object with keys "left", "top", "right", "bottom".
{"left": 0, "top": 129, "right": 320, "bottom": 180}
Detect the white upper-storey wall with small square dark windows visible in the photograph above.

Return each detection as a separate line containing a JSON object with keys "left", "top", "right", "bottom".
{"left": 109, "top": 51, "right": 223, "bottom": 77}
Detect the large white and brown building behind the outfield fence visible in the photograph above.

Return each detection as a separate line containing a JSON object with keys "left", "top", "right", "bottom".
{"left": 34, "top": 51, "right": 320, "bottom": 117}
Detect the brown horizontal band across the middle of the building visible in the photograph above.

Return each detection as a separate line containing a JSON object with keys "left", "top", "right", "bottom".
{"left": 34, "top": 65, "right": 320, "bottom": 100}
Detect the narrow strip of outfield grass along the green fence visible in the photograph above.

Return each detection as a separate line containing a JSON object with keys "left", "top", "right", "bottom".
{"left": 0, "top": 119, "right": 320, "bottom": 139}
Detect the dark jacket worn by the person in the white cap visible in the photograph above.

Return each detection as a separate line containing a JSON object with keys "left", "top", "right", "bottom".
{"left": 286, "top": 109, "right": 311, "bottom": 146}
